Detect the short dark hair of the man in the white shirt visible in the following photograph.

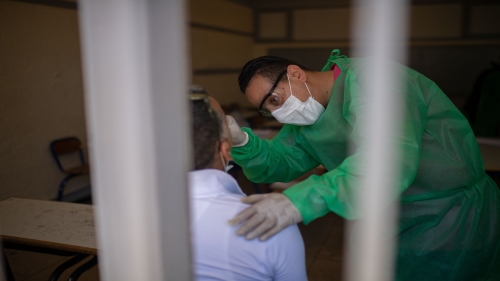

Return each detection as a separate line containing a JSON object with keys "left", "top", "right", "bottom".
{"left": 190, "top": 86, "right": 223, "bottom": 170}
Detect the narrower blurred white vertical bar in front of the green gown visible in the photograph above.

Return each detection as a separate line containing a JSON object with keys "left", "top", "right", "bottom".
{"left": 346, "top": 0, "right": 407, "bottom": 281}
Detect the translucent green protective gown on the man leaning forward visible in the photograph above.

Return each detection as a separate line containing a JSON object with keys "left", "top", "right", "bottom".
{"left": 232, "top": 50, "right": 500, "bottom": 281}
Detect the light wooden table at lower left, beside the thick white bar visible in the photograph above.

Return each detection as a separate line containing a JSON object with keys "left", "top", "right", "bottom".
{"left": 0, "top": 198, "right": 97, "bottom": 280}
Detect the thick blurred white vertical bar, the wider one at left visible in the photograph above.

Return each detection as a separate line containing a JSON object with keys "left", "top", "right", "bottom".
{"left": 79, "top": 0, "right": 191, "bottom": 281}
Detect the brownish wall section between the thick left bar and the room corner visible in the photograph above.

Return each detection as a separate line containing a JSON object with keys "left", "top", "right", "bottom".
{"left": 190, "top": 0, "right": 254, "bottom": 106}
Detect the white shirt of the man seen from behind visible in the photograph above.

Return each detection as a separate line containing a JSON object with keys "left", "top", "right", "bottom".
{"left": 189, "top": 169, "right": 307, "bottom": 281}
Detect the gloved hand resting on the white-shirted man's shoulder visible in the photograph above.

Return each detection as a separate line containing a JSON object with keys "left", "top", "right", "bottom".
{"left": 229, "top": 193, "right": 302, "bottom": 241}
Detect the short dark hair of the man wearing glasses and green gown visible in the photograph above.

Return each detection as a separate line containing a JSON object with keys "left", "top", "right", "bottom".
{"left": 238, "top": 56, "right": 310, "bottom": 94}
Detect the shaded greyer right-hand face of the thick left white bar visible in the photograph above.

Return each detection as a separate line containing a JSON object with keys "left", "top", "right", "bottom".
{"left": 147, "top": 0, "right": 194, "bottom": 281}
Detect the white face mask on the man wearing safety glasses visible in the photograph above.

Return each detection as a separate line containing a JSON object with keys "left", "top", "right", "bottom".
{"left": 271, "top": 74, "right": 325, "bottom": 125}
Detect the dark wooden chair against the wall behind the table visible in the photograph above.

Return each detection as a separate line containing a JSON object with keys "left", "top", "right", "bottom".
{"left": 50, "top": 137, "right": 90, "bottom": 201}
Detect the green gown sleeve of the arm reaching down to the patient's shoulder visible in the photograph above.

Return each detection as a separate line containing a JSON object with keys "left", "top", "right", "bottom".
{"left": 284, "top": 66, "right": 428, "bottom": 224}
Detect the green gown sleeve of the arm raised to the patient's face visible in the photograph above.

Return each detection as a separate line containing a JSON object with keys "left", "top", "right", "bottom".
{"left": 231, "top": 125, "right": 319, "bottom": 183}
